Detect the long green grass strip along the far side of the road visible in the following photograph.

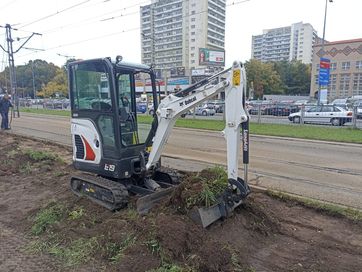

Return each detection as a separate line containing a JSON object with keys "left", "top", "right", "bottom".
{"left": 22, "top": 109, "right": 362, "bottom": 144}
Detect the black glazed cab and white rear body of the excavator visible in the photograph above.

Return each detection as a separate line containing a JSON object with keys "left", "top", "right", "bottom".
{"left": 68, "top": 58, "right": 157, "bottom": 179}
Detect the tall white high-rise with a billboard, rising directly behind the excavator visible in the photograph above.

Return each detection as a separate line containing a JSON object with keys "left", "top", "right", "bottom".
{"left": 141, "top": 0, "right": 226, "bottom": 86}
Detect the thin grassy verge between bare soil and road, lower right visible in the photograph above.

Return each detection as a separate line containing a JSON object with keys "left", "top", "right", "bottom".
{"left": 266, "top": 190, "right": 362, "bottom": 222}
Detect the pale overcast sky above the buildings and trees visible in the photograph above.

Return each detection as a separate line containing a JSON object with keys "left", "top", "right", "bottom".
{"left": 0, "top": 0, "right": 362, "bottom": 71}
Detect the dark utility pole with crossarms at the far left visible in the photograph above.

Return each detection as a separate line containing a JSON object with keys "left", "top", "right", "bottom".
{"left": 0, "top": 24, "right": 41, "bottom": 117}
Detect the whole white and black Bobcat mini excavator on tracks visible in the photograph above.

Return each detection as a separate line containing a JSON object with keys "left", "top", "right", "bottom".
{"left": 67, "top": 56, "right": 250, "bottom": 227}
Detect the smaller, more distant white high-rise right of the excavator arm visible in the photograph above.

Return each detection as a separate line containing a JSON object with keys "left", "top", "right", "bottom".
{"left": 251, "top": 22, "right": 319, "bottom": 64}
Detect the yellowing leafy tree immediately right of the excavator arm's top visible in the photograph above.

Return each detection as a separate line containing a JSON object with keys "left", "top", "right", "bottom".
{"left": 245, "top": 59, "right": 283, "bottom": 98}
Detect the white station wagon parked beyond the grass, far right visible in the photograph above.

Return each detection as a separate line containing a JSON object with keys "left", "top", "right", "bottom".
{"left": 288, "top": 105, "right": 353, "bottom": 126}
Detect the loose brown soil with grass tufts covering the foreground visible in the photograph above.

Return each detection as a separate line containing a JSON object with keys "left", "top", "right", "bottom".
{"left": 0, "top": 133, "right": 362, "bottom": 271}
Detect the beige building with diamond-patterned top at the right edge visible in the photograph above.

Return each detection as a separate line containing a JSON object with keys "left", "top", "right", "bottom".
{"left": 310, "top": 39, "right": 362, "bottom": 101}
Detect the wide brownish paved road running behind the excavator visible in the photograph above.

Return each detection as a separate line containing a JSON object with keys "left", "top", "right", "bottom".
{"left": 7, "top": 114, "right": 362, "bottom": 209}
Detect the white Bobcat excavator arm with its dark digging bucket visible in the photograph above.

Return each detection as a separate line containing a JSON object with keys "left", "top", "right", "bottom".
{"left": 141, "top": 61, "right": 250, "bottom": 227}
